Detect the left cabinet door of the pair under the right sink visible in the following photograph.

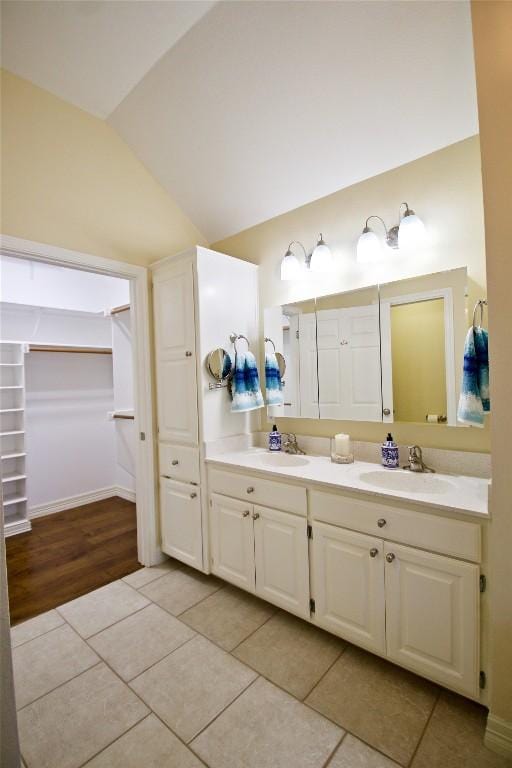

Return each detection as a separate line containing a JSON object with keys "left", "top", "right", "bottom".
{"left": 312, "top": 522, "right": 386, "bottom": 653}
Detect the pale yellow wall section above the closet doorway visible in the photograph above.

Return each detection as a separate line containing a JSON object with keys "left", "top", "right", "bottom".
{"left": 0, "top": 71, "right": 205, "bottom": 265}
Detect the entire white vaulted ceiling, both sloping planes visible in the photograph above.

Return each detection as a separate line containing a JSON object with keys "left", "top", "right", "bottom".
{"left": 2, "top": 0, "right": 478, "bottom": 242}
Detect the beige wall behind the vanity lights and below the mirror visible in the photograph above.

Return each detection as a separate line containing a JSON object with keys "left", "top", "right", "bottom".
{"left": 213, "top": 136, "right": 490, "bottom": 451}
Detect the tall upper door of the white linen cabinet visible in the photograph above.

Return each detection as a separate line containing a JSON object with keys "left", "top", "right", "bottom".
{"left": 154, "top": 263, "right": 198, "bottom": 445}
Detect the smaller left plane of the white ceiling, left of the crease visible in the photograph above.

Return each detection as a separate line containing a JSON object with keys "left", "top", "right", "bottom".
{"left": 2, "top": 0, "right": 213, "bottom": 117}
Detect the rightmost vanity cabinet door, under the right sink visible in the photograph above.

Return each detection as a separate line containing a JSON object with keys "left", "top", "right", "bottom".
{"left": 384, "top": 543, "right": 480, "bottom": 697}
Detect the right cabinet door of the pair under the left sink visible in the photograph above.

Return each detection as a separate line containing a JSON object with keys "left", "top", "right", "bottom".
{"left": 253, "top": 505, "right": 309, "bottom": 619}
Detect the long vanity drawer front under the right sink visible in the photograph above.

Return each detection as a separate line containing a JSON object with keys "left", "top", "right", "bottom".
{"left": 310, "top": 491, "right": 481, "bottom": 563}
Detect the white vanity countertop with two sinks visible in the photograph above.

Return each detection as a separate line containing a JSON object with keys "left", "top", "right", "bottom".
{"left": 206, "top": 448, "right": 489, "bottom": 517}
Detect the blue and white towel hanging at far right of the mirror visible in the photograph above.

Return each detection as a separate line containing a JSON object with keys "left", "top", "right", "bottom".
{"left": 457, "top": 328, "right": 491, "bottom": 427}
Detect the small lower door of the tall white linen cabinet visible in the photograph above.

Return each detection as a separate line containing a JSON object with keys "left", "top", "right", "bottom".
{"left": 160, "top": 479, "right": 203, "bottom": 570}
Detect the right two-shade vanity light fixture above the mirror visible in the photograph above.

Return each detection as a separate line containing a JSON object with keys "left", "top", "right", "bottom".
{"left": 357, "top": 203, "right": 425, "bottom": 264}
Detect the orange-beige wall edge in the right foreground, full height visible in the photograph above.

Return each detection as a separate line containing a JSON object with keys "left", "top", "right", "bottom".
{"left": 472, "top": 2, "right": 512, "bottom": 738}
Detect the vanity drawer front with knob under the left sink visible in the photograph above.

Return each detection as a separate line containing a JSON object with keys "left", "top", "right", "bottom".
{"left": 209, "top": 469, "right": 307, "bottom": 517}
